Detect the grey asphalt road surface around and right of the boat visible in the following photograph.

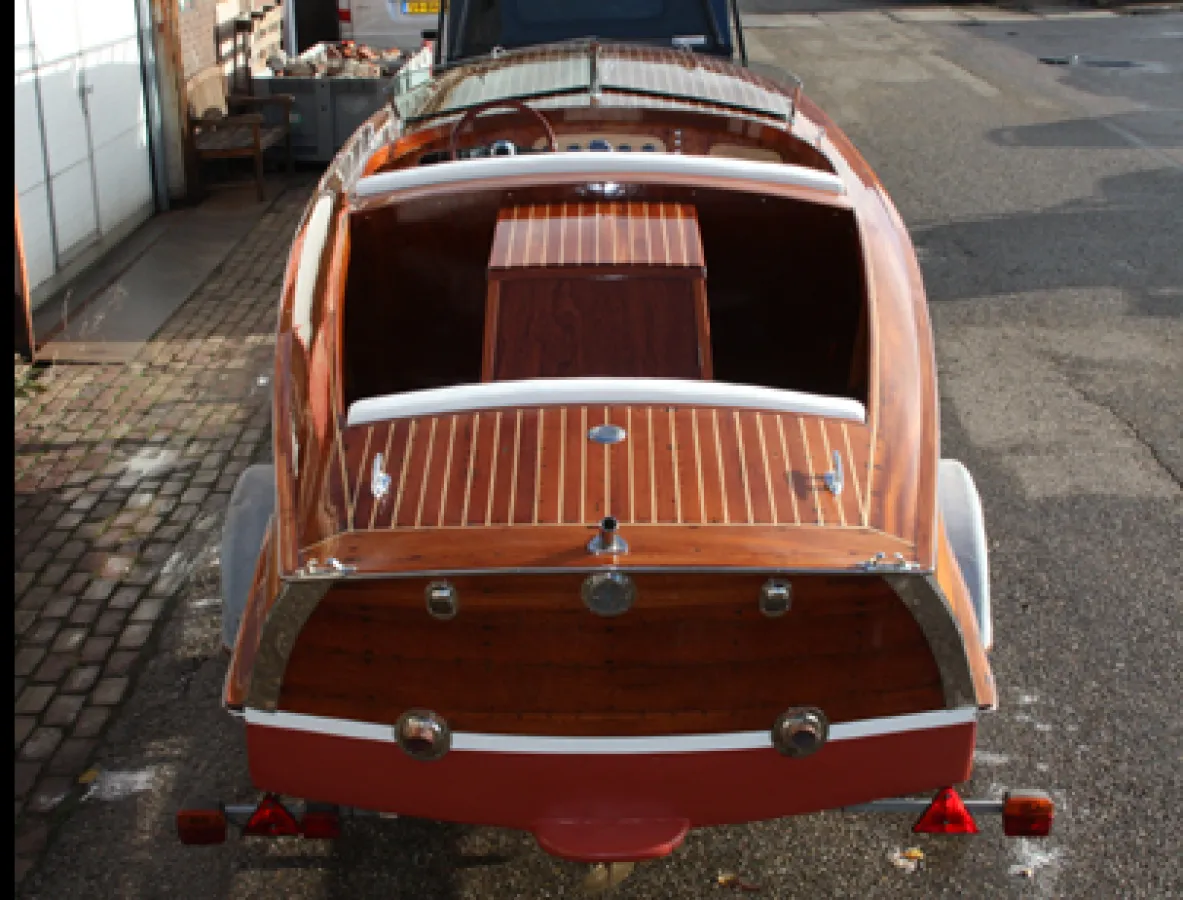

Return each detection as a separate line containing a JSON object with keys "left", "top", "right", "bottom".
{"left": 16, "top": 0, "right": 1183, "bottom": 898}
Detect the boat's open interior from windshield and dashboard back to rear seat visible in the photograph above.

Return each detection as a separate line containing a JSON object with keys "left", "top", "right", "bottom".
{"left": 309, "top": 51, "right": 870, "bottom": 425}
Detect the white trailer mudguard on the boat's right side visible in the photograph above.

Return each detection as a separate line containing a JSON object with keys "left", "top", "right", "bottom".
{"left": 937, "top": 459, "right": 994, "bottom": 649}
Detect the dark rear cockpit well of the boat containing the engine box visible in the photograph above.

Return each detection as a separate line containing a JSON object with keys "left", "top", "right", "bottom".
{"left": 342, "top": 166, "right": 868, "bottom": 406}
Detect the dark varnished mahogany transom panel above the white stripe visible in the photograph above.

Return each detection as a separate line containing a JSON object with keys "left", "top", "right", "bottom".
{"left": 277, "top": 572, "right": 945, "bottom": 738}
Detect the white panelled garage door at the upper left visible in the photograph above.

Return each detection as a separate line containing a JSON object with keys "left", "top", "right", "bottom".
{"left": 15, "top": 0, "right": 153, "bottom": 302}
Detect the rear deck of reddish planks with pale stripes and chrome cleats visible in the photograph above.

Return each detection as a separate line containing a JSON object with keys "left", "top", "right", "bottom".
{"left": 322, "top": 406, "right": 873, "bottom": 541}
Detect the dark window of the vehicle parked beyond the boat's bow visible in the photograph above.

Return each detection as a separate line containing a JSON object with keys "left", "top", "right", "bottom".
{"left": 450, "top": 0, "right": 730, "bottom": 59}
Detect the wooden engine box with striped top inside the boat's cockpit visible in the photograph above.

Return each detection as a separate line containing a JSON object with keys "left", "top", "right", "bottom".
{"left": 481, "top": 202, "right": 711, "bottom": 381}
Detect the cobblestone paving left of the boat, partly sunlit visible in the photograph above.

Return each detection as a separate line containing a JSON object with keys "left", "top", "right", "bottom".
{"left": 14, "top": 176, "right": 312, "bottom": 883}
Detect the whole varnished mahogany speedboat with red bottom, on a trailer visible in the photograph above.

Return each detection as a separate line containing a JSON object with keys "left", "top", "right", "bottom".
{"left": 182, "top": 41, "right": 1052, "bottom": 861}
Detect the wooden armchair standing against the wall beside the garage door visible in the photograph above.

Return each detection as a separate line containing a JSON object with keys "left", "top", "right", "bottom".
{"left": 186, "top": 66, "right": 296, "bottom": 200}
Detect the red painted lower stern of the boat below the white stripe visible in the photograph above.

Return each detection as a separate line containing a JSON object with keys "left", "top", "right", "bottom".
{"left": 246, "top": 723, "right": 976, "bottom": 861}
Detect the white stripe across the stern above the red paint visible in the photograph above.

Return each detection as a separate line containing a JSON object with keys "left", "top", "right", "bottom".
{"left": 245, "top": 706, "right": 977, "bottom": 753}
